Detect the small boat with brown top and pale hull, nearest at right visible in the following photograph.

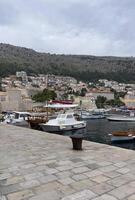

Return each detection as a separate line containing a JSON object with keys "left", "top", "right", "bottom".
{"left": 111, "top": 130, "right": 135, "bottom": 142}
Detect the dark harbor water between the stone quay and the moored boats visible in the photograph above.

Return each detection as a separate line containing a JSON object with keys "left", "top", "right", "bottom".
{"left": 62, "top": 119, "right": 135, "bottom": 150}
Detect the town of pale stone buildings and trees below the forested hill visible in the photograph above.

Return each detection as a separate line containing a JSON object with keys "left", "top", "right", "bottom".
{"left": 0, "top": 71, "right": 135, "bottom": 112}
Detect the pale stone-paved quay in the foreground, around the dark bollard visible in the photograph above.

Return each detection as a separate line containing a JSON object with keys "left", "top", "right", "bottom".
{"left": 0, "top": 125, "right": 135, "bottom": 200}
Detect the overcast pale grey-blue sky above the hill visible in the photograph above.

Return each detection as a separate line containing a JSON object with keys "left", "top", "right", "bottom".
{"left": 0, "top": 0, "right": 135, "bottom": 56}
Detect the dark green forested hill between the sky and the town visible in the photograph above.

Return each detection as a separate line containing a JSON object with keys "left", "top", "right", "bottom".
{"left": 0, "top": 43, "right": 135, "bottom": 82}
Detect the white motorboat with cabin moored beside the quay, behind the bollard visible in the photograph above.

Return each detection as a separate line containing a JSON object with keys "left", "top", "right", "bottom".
{"left": 40, "top": 113, "right": 86, "bottom": 132}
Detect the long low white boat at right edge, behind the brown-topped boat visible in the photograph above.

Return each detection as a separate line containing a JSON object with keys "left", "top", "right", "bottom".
{"left": 107, "top": 115, "right": 135, "bottom": 122}
